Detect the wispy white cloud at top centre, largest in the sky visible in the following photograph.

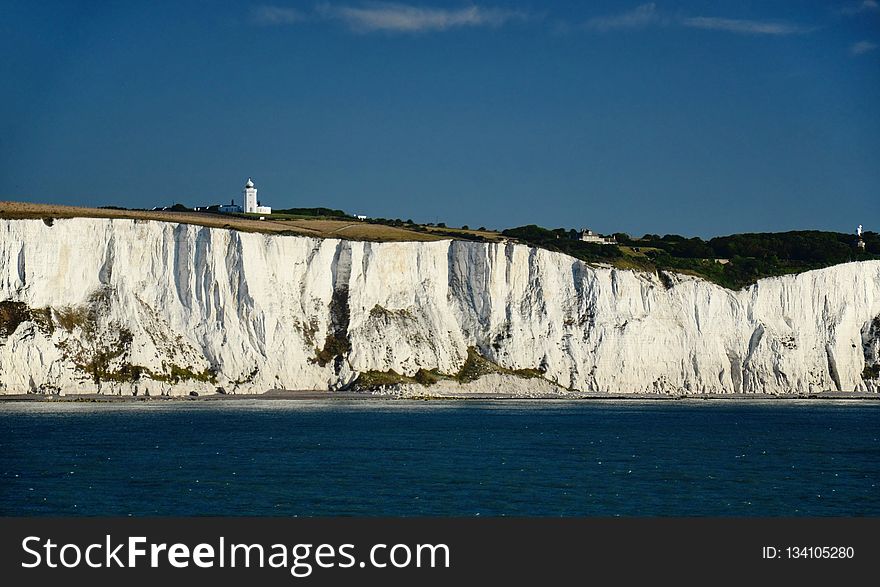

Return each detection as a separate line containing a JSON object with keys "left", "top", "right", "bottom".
{"left": 317, "top": 2, "right": 526, "bottom": 33}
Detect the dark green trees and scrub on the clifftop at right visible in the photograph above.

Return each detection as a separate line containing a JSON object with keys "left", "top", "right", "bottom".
{"left": 502, "top": 225, "right": 880, "bottom": 289}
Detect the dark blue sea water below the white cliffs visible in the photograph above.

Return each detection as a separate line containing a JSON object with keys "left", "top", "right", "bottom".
{"left": 0, "top": 400, "right": 880, "bottom": 516}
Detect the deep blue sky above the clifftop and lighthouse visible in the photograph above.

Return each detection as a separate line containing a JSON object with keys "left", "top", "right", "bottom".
{"left": 0, "top": 0, "right": 880, "bottom": 236}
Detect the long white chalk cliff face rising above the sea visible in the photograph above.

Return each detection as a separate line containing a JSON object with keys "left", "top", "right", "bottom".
{"left": 0, "top": 219, "right": 880, "bottom": 394}
